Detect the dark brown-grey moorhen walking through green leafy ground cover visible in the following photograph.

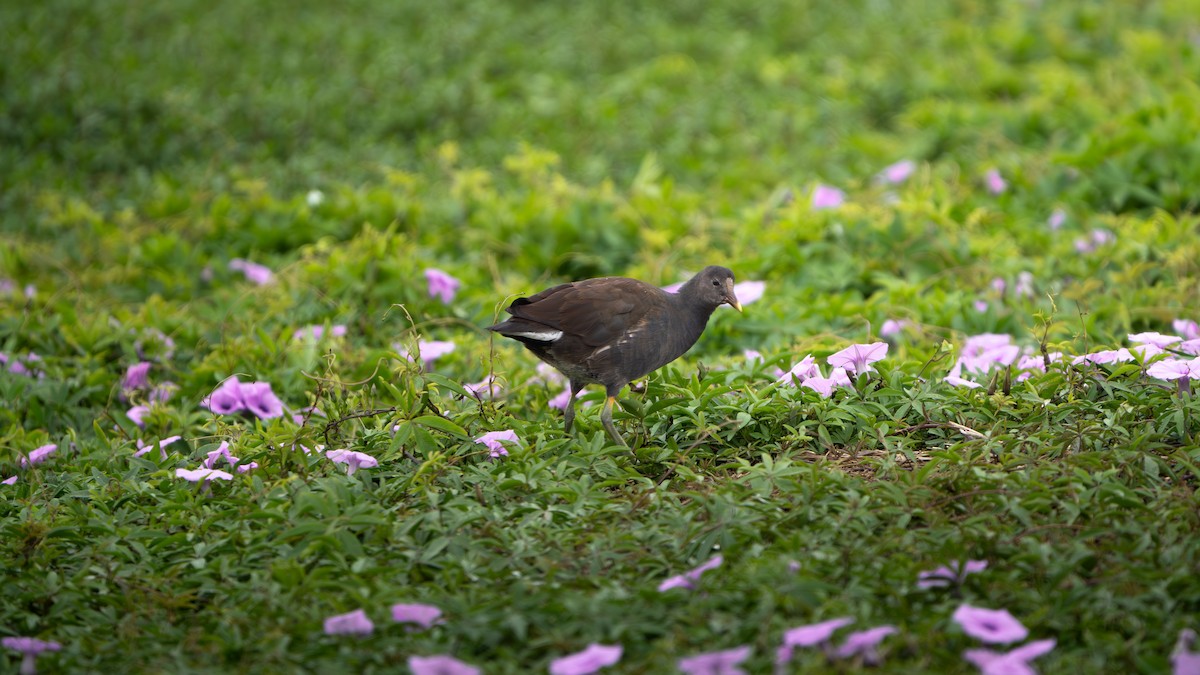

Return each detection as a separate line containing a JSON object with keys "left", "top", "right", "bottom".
{"left": 488, "top": 265, "right": 742, "bottom": 448}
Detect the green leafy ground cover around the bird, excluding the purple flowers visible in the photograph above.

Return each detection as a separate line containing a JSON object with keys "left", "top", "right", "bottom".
{"left": 0, "top": 0, "right": 1200, "bottom": 674}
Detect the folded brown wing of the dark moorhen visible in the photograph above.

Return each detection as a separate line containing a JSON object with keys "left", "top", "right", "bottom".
{"left": 508, "top": 277, "right": 666, "bottom": 347}
